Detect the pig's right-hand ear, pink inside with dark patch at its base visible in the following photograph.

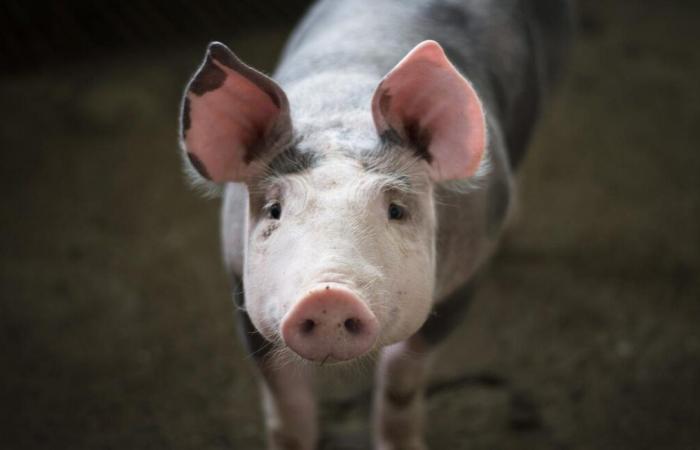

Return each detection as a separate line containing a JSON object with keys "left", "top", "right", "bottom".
{"left": 372, "top": 41, "right": 486, "bottom": 181}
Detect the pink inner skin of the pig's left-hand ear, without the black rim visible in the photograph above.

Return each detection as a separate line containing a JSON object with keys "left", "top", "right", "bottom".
{"left": 185, "top": 58, "right": 280, "bottom": 182}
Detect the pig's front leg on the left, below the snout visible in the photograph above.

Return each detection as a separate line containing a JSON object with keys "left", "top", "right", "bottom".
{"left": 234, "top": 278, "right": 318, "bottom": 450}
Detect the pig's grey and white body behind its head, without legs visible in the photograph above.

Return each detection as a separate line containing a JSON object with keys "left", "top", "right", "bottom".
{"left": 222, "top": 0, "right": 569, "bottom": 338}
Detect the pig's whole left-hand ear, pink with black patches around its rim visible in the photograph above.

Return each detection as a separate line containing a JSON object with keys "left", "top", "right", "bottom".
{"left": 180, "top": 42, "right": 292, "bottom": 182}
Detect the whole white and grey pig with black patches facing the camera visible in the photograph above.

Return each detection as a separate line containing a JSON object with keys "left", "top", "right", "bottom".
{"left": 180, "top": 0, "right": 571, "bottom": 450}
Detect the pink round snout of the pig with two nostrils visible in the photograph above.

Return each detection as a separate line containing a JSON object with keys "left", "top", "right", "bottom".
{"left": 281, "top": 286, "right": 379, "bottom": 362}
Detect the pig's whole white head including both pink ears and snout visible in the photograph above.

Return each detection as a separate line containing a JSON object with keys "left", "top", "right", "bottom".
{"left": 181, "top": 41, "right": 485, "bottom": 362}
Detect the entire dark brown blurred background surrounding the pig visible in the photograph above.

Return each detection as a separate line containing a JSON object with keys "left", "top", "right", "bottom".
{"left": 0, "top": 0, "right": 700, "bottom": 450}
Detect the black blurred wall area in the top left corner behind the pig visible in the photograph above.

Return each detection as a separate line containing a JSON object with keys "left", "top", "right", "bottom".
{"left": 0, "top": 0, "right": 311, "bottom": 72}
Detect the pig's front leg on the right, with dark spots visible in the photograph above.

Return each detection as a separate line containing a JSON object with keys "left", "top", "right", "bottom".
{"left": 374, "top": 283, "right": 473, "bottom": 450}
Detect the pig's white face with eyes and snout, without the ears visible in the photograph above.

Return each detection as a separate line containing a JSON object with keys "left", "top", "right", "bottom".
{"left": 244, "top": 154, "right": 435, "bottom": 361}
